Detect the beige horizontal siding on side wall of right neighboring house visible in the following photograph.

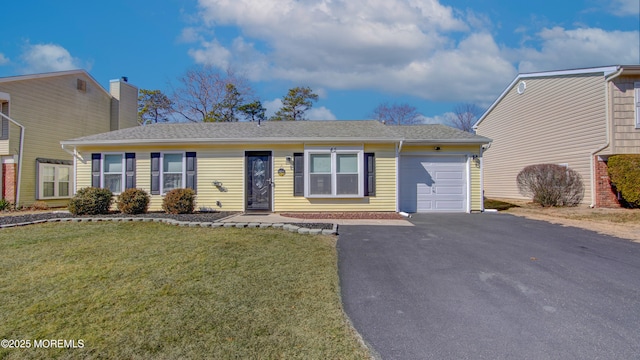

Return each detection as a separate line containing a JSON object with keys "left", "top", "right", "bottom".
{"left": 477, "top": 73, "right": 607, "bottom": 203}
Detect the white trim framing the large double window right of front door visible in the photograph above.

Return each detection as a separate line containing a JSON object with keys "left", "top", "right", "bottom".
{"left": 304, "top": 147, "right": 365, "bottom": 199}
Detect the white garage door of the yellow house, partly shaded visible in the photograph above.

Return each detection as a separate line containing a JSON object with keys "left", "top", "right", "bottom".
{"left": 400, "top": 156, "right": 467, "bottom": 213}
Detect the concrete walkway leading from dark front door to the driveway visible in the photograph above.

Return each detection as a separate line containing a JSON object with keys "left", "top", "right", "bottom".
{"left": 220, "top": 213, "right": 413, "bottom": 226}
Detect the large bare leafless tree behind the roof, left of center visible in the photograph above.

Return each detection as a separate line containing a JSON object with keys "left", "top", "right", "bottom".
{"left": 172, "top": 66, "right": 253, "bottom": 122}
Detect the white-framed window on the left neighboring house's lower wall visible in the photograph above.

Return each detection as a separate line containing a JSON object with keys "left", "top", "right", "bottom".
{"left": 36, "top": 159, "right": 72, "bottom": 200}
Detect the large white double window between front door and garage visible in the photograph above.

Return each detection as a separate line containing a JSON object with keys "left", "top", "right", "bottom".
{"left": 304, "top": 148, "right": 364, "bottom": 197}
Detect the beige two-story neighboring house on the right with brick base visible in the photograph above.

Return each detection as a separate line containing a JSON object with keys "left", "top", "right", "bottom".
{"left": 474, "top": 65, "right": 640, "bottom": 207}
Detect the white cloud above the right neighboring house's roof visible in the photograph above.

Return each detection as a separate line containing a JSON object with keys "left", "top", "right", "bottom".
{"left": 511, "top": 27, "right": 640, "bottom": 72}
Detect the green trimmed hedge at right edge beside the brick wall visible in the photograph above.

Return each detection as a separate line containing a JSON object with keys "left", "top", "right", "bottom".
{"left": 607, "top": 155, "right": 640, "bottom": 207}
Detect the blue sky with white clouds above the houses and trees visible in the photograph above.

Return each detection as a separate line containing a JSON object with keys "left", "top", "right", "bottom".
{"left": 0, "top": 0, "right": 640, "bottom": 122}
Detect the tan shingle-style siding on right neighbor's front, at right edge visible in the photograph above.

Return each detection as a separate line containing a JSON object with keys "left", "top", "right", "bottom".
{"left": 601, "top": 77, "right": 640, "bottom": 154}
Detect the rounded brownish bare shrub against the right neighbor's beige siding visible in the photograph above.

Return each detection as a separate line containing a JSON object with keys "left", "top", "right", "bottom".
{"left": 516, "top": 164, "right": 584, "bottom": 207}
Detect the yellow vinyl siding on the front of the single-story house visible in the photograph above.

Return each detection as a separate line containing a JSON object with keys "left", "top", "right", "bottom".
{"left": 76, "top": 144, "right": 396, "bottom": 212}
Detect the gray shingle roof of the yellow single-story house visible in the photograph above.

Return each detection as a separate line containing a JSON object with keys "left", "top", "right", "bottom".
{"left": 62, "top": 120, "right": 488, "bottom": 145}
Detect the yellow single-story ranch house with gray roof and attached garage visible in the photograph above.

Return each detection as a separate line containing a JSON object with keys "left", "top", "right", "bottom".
{"left": 61, "top": 121, "right": 491, "bottom": 213}
